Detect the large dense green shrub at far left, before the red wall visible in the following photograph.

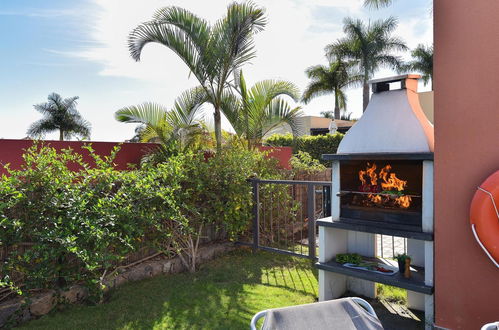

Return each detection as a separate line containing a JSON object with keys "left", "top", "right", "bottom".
{"left": 0, "top": 146, "right": 185, "bottom": 293}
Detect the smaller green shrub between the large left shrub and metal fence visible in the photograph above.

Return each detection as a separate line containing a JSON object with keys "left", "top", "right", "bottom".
{"left": 184, "top": 147, "right": 282, "bottom": 238}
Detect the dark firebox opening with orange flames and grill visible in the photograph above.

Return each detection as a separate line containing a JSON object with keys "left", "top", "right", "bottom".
{"left": 340, "top": 160, "right": 423, "bottom": 227}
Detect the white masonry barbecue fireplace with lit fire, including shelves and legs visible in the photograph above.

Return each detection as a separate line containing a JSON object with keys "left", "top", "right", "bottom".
{"left": 317, "top": 75, "right": 434, "bottom": 324}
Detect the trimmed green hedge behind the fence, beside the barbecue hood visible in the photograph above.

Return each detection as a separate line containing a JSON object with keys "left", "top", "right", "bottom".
{"left": 265, "top": 133, "right": 343, "bottom": 167}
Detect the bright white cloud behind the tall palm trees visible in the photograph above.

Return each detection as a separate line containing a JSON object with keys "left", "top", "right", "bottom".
{"left": 54, "top": 0, "right": 432, "bottom": 139}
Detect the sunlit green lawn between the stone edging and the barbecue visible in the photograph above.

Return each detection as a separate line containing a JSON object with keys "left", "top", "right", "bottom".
{"left": 21, "top": 250, "right": 318, "bottom": 330}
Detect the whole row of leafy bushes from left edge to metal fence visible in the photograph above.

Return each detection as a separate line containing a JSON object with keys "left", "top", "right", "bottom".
{"left": 0, "top": 145, "right": 288, "bottom": 298}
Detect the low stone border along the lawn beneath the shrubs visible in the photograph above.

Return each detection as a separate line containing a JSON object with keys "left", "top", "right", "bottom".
{"left": 0, "top": 243, "right": 236, "bottom": 328}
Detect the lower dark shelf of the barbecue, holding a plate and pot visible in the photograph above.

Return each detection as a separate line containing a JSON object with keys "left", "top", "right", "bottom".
{"left": 315, "top": 260, "right": 433, "bottom": 295}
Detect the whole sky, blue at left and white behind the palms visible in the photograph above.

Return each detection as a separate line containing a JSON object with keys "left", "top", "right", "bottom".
{"left": 0, "top": 0, "right": 433, "bottom": 141}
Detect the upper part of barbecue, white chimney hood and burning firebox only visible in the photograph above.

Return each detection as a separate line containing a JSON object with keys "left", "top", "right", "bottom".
{"left": 324, "top": 75, "right": 433, "bottom": 232}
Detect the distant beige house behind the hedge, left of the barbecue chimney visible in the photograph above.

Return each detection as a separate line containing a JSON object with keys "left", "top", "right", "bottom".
{"left": 266, "top": 116, "right": 355, "bottom": 137}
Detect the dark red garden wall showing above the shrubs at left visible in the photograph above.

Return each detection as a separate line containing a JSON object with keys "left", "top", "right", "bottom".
{"left": 0, "top": 139, "right": 157, "bottom": 174}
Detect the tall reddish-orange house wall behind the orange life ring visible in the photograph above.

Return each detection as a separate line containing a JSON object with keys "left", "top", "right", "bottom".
{"left": 434, "top": 0, "right": 499, "bottom": 329}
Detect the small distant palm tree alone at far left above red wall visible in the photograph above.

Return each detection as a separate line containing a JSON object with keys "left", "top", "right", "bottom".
{"left": 27, "top": 93, "right": 91, "bottom": 141}
